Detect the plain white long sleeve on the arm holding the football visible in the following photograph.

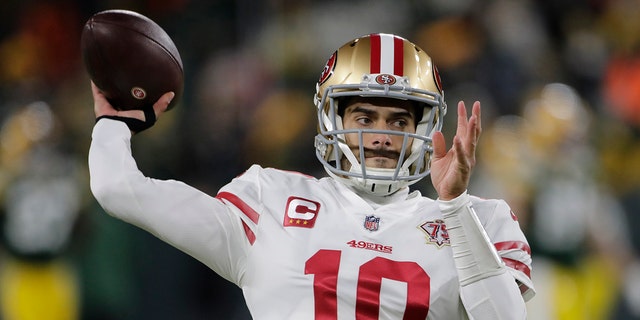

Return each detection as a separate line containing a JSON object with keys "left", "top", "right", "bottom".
{"left": 89, "top": 119, "right": 249, "bottom": 284}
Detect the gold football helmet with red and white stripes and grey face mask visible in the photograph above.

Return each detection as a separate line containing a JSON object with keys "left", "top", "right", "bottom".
{"left": 314, "top": 33, "right": 447, "bottom": 195}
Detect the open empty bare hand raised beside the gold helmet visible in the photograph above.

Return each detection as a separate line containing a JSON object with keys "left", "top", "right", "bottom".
{"left": 431, "top": 101, "right": 482, "bottom": 200}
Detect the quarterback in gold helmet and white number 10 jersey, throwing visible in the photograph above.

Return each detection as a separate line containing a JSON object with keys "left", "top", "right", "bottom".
{"left": 89, "top": 34, "right": 535, "bottom": 319}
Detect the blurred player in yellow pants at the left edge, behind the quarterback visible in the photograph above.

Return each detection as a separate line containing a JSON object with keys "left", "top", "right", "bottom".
{"left": 0, "top": 101, "right": 85, "bottom": 320}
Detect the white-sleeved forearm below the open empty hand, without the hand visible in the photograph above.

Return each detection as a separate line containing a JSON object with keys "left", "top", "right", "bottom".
{"left": 439, "top": 192, "right": 526, "bottom": 319}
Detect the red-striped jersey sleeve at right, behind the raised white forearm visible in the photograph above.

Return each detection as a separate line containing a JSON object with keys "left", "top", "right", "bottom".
{"left": 474, "top": 200, "right": 535, "bottom": 301}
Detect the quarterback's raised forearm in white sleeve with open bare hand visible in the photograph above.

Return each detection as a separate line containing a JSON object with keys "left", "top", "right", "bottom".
{"left": 431, "top": 101, "right": 527, "bottom": 320}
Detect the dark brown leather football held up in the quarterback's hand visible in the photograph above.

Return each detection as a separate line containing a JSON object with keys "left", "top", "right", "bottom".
{"left": 80, "top": 10, "right": 184, "bottom": 110}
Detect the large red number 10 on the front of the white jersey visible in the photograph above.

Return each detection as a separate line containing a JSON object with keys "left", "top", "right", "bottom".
{"left": 305, "top": 250, "right": 430, "bottom": 320}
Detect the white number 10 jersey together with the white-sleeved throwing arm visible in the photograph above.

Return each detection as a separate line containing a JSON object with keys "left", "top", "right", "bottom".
{"left": 89, "top": 120, "right": 533, "bottom": 320}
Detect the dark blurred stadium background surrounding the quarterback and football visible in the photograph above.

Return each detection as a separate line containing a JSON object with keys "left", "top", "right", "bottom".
{"left": 0, "top": 0, "right": 640, "bottom": 320}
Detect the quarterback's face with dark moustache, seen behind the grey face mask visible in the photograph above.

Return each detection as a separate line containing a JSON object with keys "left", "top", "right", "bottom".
{"left": 343, "top": 98, "right": 416, "bottom": 169}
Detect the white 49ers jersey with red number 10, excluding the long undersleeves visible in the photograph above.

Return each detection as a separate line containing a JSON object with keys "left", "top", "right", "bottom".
{"left": 217, "top": 166, "right": 531, "bottom": 319}
